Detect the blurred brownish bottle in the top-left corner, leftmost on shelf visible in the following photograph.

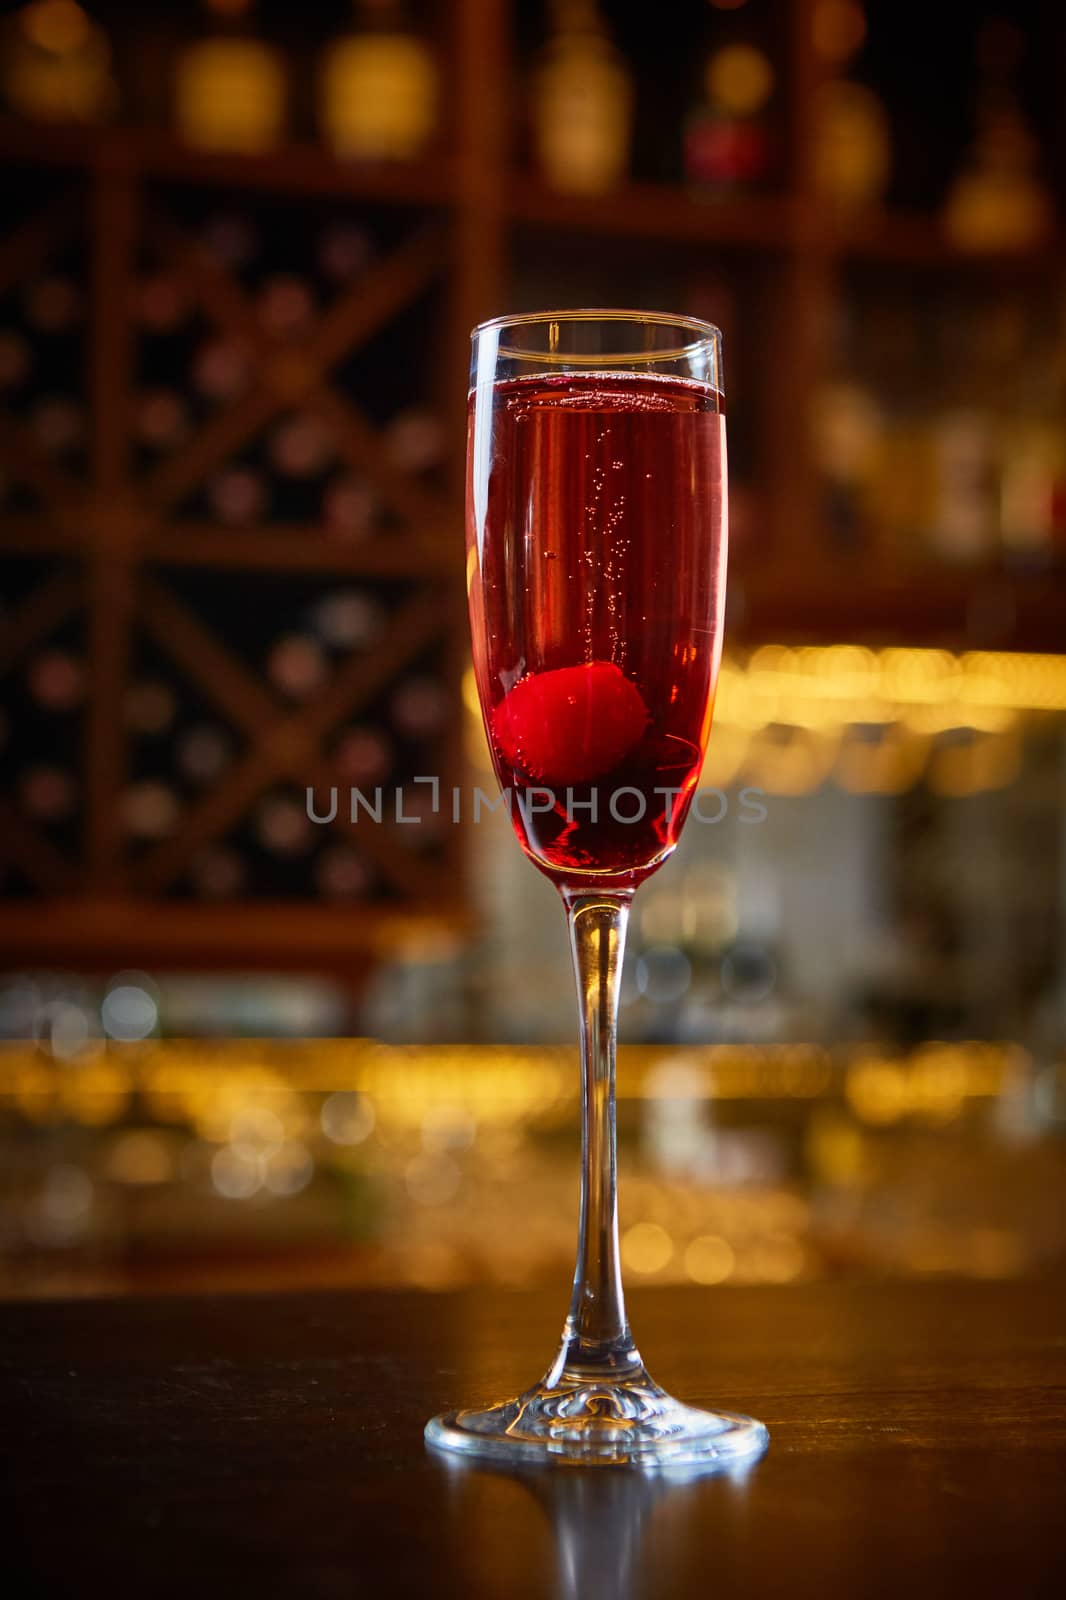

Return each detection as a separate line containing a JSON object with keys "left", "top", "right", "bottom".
{"left": 0, "top": 0, "right": 118, "bottom": 123}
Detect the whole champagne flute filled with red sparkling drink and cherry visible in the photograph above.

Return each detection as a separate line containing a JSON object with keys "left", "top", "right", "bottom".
{"left": 426, "top": 310, "right": 768, "bottom": 1470}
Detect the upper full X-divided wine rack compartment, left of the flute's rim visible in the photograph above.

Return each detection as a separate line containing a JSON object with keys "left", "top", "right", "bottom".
{"left": 133, "top": 194, "right": 445, "bottom": 546}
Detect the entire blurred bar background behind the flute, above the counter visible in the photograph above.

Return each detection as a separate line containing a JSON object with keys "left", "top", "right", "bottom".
{"left": 0, "top": 0, "right": 1066, "bottom": 1296}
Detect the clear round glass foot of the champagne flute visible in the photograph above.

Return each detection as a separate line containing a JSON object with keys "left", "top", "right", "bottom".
{"left": 426, "top": 1368, "right": 770, "bottom": 1472}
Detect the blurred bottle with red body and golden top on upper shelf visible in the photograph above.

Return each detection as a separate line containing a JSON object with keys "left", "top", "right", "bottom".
{"left": 685, "top": 42, "right": 773, "bottom": 192}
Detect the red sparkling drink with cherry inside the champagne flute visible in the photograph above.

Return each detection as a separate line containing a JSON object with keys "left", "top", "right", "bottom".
{"left": 467, "top": 374, "right": 725, "bottom": 888}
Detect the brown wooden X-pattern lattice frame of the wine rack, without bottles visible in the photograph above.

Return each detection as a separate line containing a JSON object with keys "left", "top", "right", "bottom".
{"left": 0, "top": 34, "right": 467, "bottom": 960}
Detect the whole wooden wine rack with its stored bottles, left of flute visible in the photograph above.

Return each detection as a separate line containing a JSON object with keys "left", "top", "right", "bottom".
{"left": 0, "top": 124, "right": 463, "bottom": 973}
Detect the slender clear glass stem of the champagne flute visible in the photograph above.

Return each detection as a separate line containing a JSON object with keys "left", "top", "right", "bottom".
{"left": 549, "top": 890, "right": 640, "bottom": 1382}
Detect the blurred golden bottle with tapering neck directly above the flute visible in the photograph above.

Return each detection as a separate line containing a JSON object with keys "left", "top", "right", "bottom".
{"left": 531, "top": 0, "right": 632, "bottom": 194}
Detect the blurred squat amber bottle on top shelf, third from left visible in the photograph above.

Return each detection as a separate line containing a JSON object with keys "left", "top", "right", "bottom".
{"left": 319, "top": 0, "right": 439, "bottom": 162}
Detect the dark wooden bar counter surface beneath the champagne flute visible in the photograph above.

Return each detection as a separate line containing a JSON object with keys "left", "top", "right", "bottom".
{"left": 0, "top": 1283, "right": 1066, "bottom": 1600}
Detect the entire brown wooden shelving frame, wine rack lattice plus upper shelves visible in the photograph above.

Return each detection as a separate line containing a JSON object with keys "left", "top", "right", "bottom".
{"left": 0, "top": 0, "right": 1066, "bottom": 973}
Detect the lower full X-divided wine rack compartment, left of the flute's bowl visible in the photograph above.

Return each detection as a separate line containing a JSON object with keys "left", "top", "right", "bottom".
{"left": 125, "top": 570, "right": 455, "bottom": 902}
